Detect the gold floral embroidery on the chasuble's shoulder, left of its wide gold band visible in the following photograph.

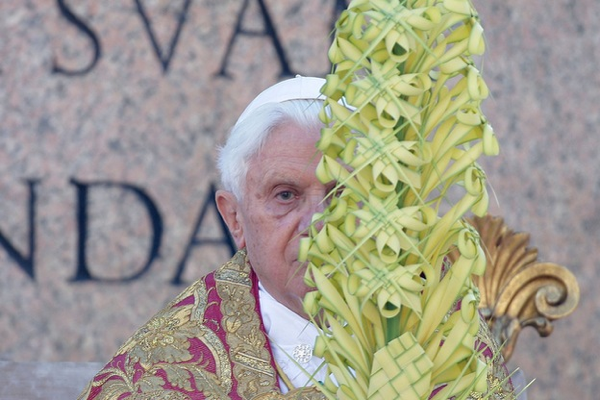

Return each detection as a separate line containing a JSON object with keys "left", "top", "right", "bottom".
{"left": 80, "top": 280, "right": 233, "bottom": 400}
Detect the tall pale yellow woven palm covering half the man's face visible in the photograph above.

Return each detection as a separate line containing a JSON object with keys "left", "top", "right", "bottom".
{"left": 300, "top": 0, "right": 499, "bottom": 399}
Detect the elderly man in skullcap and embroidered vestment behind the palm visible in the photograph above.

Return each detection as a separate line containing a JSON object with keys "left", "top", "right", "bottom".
{"left": 80, "top": 77, "right": 510, "bottom": 400}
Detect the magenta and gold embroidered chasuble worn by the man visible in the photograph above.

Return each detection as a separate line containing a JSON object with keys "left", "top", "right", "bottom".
{"left": 79, "top": 250, "right": 514, "bottom": 400}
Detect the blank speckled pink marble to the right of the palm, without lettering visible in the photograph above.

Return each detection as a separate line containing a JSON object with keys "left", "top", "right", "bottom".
{"left": 477, "top": 0, "right": 600, "bottom": 399}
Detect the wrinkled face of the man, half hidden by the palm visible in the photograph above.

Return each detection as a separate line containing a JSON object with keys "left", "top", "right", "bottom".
{"left": 217, "top": 123, "right": 331, "bottom": 315}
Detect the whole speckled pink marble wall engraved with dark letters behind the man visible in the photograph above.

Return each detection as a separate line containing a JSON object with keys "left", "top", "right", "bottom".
{"left": 0, "top": 0, "right": 600, "bottom": 399}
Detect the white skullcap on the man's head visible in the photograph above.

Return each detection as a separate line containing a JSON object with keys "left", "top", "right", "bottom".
{"left": 236, "top": 75, "right": 325, "bottom": 125}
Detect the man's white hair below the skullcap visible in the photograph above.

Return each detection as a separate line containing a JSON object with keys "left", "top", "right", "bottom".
{"left": 217, "top": 100, "right": 323, "bottom": 201}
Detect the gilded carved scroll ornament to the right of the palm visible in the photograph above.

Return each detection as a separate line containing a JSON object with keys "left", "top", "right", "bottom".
{"left": 450, "top": 215, "right": 579, "bottom": 361}
